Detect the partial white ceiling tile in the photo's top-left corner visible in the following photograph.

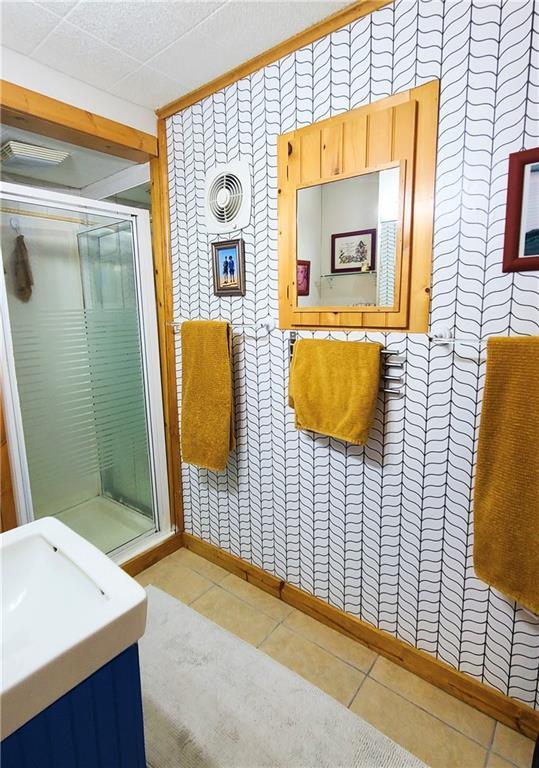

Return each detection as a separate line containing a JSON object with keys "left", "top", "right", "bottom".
{"left": 0, "top": 2, "right": 59, "bottom": 55}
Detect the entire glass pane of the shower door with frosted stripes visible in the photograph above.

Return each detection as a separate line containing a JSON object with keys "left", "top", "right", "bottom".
{"left": 2, "top": 203, "right": 155, "bottom": 551}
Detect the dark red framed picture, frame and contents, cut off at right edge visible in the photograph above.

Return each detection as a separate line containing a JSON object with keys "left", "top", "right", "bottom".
{"left": 502, "top": 147, "right": 539, "bottom": 272}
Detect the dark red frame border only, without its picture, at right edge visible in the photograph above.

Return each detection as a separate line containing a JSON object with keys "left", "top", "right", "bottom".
{"left": 503, "top": 147, "right": 539, "bottom": 272}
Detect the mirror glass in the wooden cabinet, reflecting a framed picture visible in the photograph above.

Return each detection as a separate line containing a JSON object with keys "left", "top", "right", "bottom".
{"left": 296, "top": 166, "right": 400, "bottom": 307}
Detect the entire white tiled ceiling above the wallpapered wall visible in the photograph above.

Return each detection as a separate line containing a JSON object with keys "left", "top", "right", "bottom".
{"left": 0, "top": 0, "right": 350, "bottom": 109}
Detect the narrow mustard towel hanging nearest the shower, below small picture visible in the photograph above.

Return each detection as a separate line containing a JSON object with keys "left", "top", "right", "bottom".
{"left": 181, "top": 320, "right": 235, "bottom": 472}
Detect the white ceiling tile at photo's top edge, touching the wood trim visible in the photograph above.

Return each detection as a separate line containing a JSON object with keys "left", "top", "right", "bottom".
{"left": 194, "top": 0, "right": 349, "bottom": 61}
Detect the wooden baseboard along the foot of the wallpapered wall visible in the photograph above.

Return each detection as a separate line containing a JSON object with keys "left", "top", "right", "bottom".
{"left": 183, "top": 533, "right": 539, "bottom": 739}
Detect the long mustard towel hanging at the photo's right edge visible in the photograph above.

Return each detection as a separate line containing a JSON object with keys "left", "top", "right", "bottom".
{"left": 474, "top": 336, "right": 539, "bottom": 614}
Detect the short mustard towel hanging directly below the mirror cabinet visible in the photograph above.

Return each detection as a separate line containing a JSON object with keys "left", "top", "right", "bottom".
{"left": 288, "top": 339, "right": 382, "bottom": 445}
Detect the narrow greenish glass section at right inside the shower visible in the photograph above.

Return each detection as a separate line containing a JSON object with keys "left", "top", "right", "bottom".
{"left": 78, "top": 222, "right": 152, "bottom": 517}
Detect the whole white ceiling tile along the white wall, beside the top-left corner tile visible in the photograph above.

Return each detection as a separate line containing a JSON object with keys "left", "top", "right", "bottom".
{"left": 32, "top": 21, "right": 140, "bottom": 90}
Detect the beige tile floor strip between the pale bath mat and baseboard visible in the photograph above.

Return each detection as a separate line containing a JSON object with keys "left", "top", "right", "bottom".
{"left": 137, "top": 549, "right": 534, "bottom": 768}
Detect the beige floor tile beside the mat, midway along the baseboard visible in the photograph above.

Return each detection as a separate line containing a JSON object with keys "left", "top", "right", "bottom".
{"left": 260, "top": 624, "right": 365, "bottom": 706}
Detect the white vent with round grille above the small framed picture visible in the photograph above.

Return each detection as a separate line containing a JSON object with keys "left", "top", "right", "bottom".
{"left": 206, "top": 160, "right": 251, "bottom": 234}
